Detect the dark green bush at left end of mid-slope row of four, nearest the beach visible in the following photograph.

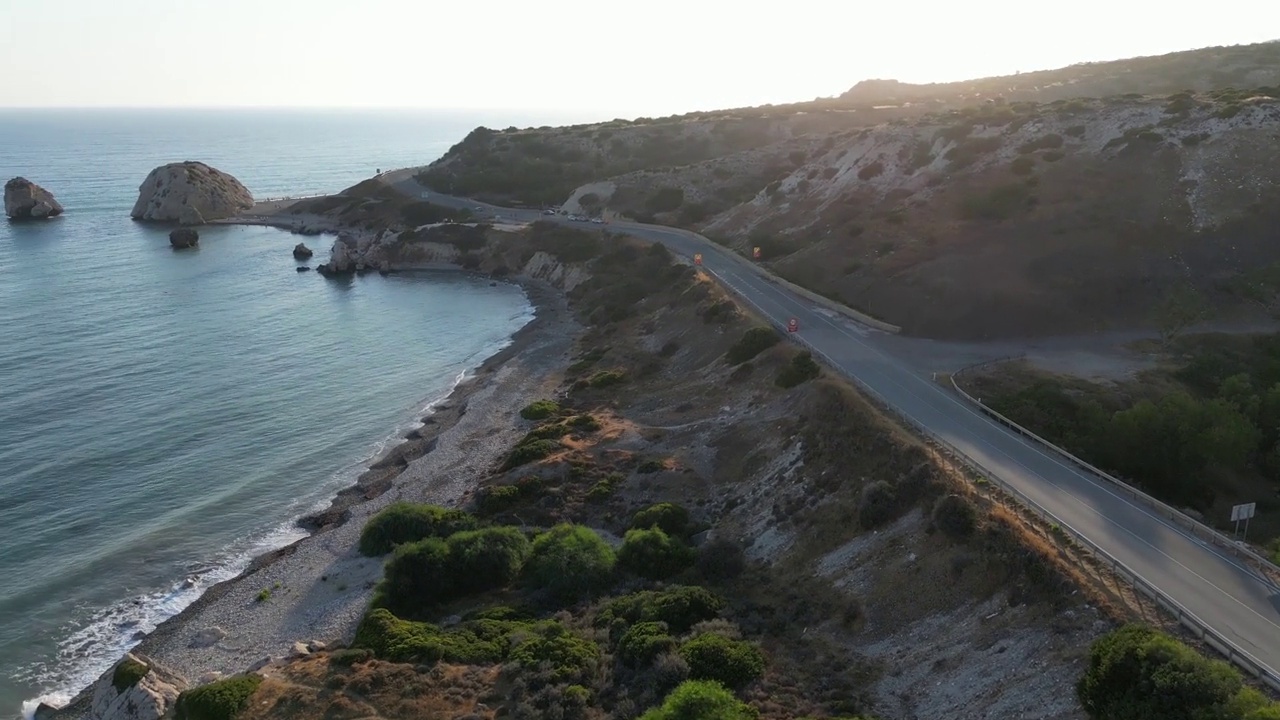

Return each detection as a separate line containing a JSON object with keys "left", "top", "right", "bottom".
{"left": 375, "top": 538, "right": 462, "bottom": 607}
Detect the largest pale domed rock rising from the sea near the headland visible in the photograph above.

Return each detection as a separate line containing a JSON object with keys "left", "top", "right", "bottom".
{"left": 129, "top": 160, "right": 253, "bottom": 224}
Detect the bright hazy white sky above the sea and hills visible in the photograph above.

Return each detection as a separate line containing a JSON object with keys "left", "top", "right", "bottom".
{"left": 0, "top": 0, "right": 1280, "bottom": 117}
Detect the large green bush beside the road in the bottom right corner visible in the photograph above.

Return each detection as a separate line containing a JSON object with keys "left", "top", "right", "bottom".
{"left": 1076, "top": 625, "right": 1243, "bottom": 720}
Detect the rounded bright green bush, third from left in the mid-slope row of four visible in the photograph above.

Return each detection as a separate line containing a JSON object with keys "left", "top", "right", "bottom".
{"left": 525, "top": 524, "right": 616, "bottom": 602}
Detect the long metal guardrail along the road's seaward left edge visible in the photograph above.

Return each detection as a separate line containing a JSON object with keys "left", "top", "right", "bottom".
{"left": 704, "top": 262, "right": 1280, "bottom": 692}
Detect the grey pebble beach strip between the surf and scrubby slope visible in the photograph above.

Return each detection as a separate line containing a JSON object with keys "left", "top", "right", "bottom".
{"left": 41, "top": 221, "right": 579, "bottom": 719}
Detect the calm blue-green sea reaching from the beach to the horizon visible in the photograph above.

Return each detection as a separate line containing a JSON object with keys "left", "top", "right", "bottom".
{"left": 0, "top": 103, "right": 590, "bottom": 717}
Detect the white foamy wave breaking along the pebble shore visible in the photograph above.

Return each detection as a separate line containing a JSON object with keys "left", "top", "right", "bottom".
{"left": 14, "top": 361, "right": 483, "bottom": 720}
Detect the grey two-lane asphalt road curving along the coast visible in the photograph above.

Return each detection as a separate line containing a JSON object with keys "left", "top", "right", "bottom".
{"left": 397, "top": 179, "right": 1280, "bottom": 676}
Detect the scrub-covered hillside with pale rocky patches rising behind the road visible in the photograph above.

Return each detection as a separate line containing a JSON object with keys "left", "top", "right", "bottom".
{"left": 419, "top": 44, "right": 1280, "bottom": 340}
